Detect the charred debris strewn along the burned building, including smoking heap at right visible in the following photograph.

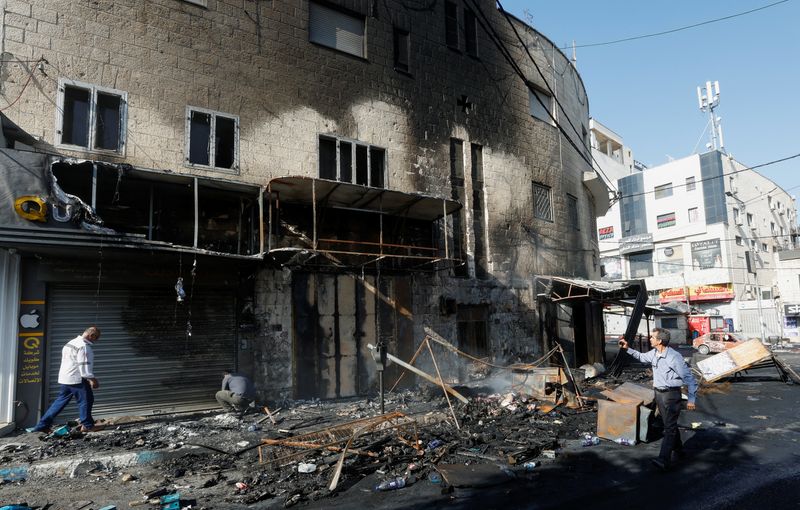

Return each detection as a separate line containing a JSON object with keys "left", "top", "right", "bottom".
{"left": 0, "top": 337, "right": 664, "bottom": 508}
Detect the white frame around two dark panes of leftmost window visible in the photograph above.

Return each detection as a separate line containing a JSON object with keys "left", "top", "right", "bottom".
{"left": 55, "top": 78, "right": 128, "bottom": 156}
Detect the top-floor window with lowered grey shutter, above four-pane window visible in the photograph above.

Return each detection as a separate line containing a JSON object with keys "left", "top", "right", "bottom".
{"left": 308, "top": 2, "right": 367, "bottom": 58}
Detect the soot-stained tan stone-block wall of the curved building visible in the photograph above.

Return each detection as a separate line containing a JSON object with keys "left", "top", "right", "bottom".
{"left": 0, "top": 0, "right": 599, "bottom": 406}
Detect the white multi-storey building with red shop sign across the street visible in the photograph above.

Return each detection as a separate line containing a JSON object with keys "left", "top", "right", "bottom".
{"left": 596, "top": 144, "right": 800, "bottom": 342}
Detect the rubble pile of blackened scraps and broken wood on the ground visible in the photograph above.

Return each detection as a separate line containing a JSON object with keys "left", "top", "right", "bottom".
{"left": 0, "top": 372, "right": 638, "bottom": 508}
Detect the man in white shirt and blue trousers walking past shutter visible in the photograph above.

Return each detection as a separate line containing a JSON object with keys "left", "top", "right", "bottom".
{"left": 28, "top": 326, "right": 100, "bottom": 432}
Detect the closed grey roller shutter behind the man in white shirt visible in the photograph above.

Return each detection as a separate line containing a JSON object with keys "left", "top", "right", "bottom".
{"left": 47, "top": 285, "right": 236, "bottom": 418}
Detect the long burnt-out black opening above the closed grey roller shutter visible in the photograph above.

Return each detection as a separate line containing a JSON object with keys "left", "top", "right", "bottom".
{"left": 43, "top": 161, "right": 261, "bottom": 256}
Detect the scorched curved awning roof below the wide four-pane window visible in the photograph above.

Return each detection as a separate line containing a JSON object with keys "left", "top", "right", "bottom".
{"left": 267, "top": 176, "right": 461, "bottom": 221}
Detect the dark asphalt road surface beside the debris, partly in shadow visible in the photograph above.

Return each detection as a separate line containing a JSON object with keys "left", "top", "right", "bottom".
{"left": 300, "top": 349, "right": 800, "bottom": 510}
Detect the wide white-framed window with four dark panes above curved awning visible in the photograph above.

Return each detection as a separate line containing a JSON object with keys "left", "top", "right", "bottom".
{"left": 319, "top": 136, "right": 386, "bottom": 188}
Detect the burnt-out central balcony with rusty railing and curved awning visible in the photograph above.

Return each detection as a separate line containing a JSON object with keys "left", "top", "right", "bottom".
{"left": 267, "top": 177, "right": 461, "bottom": 271}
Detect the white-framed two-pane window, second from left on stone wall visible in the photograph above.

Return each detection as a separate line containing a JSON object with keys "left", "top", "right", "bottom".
{"left": 186, "top": 106, "right": 239, "bottom": 171}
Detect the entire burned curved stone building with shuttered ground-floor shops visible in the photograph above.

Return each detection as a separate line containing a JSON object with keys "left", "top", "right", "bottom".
{"left": 0, "top": 0, "right": 608, "bottom": 432}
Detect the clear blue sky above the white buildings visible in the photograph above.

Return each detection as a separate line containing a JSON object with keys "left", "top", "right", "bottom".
{"left": 501, "top": 0, "right": 800, "bottom": 198}
